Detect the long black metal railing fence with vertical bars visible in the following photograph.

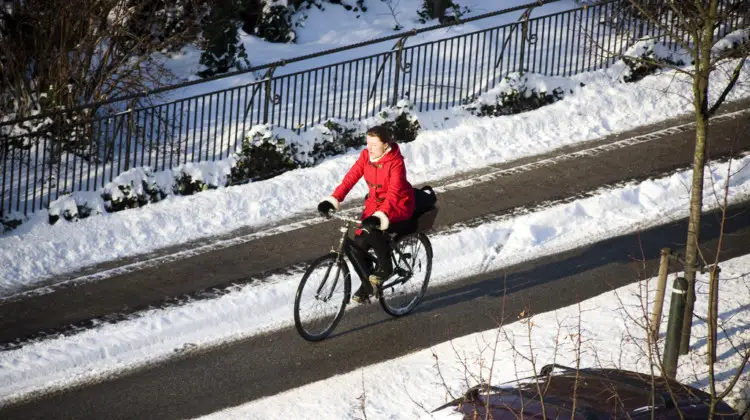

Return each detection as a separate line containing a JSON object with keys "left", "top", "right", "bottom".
{"left": 0, "top": 0, "right": 746, "bottom": 216}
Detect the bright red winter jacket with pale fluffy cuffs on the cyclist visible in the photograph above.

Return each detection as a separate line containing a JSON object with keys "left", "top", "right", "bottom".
{"left": 331, "top": 143, "right": 415, "bottom": 230}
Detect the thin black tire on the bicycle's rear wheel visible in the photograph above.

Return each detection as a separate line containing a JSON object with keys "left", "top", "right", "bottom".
{"left": 378, "top": 233, "right": 432, "bottom": 317}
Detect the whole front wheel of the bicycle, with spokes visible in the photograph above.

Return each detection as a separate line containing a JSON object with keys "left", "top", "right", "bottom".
{"left": 294, "top": 253, "right": 351, "bottom": 341}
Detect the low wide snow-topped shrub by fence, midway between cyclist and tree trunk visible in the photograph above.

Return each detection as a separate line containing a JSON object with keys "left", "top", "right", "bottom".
{"left": 463, "top": 73, "right": 582, "bottom": 117}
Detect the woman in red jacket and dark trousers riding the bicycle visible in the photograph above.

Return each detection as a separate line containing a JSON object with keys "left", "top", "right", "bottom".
{"left": 318, "top": 126, "right": 415, "bottom": 303}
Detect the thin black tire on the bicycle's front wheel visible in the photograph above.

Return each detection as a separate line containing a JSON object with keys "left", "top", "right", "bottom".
{"left": 294, "top": 252, "right": 351, "bottom": 341}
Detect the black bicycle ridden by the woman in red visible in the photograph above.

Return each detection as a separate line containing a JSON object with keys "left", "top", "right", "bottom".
{"left": 294, "top": 209, "right": 437, "bottom": 341}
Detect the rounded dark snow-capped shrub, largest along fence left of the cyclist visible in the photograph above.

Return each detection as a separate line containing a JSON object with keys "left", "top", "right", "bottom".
{"left": 231, "top": 124, "right": 298, "bottom": 184}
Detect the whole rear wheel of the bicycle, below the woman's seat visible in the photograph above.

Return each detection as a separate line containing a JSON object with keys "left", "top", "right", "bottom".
{"left": 379, "top": 233, "right": 432, "bottom": 316}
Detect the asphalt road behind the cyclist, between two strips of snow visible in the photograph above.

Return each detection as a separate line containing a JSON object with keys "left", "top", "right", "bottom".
{"left": 0, "top": 101, "right": 750, "bottom": 347}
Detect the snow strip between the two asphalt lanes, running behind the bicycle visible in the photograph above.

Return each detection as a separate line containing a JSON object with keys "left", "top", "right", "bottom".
{"left": 0, "top": 155, "right": 750, "bottom": 408}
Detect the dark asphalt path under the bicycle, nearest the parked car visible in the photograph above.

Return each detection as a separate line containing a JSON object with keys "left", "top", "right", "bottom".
{"left": 0, "top": 204, "right": 750, "bottom": 420}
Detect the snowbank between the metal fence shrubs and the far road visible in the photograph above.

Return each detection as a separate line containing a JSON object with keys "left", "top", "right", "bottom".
{"left": 0, "top": 56, "right": 750, "bottom": 296}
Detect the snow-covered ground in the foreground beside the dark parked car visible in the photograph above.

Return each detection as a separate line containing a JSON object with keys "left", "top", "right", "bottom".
{"left": 201, "top": 255, "right": 750, "bottom": 420}
